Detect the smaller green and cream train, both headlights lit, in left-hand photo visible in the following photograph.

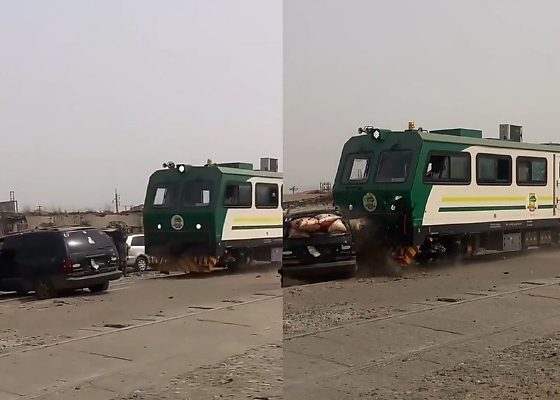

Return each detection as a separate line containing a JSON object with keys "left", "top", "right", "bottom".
{"left": 143, "top": 159, "right": 283, "bottom": 273}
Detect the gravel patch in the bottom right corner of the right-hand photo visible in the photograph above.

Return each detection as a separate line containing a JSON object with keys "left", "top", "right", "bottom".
{"left": 368, "top": 333, "right": 560, "bottom": 400}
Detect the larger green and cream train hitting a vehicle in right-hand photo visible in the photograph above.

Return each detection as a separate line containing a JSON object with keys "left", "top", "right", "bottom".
{"left": 333, "top": 123, "right": 560, "bottom": 265}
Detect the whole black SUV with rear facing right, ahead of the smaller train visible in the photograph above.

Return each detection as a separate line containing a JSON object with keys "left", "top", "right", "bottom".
{"left": 0, "top": 227, "right": 121, "bottom": 299}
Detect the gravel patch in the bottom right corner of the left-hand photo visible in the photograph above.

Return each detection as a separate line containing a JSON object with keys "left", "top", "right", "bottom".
{"left": 121, "top": 345, "right": 282, "bottom": 400}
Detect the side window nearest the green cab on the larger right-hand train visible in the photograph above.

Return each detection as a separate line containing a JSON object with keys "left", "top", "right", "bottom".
{"left": 424, "top": 153, "right": 471, "bottom": 184}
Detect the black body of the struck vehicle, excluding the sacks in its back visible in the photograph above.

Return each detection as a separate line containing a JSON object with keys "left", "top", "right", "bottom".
{"left": 279, "top": 208, "right": 356, "bottom": 279}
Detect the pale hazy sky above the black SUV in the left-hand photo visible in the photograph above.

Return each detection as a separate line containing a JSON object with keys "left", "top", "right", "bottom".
{"left": 0, "top": 0, "right": 282, "bottom": 209}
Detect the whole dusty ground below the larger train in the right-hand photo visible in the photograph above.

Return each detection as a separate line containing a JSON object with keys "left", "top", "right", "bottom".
{"left": 284, "top": 250, "right": 560, "bottom": 400}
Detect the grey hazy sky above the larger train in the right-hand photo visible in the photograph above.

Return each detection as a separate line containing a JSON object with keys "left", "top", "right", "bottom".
{"left": 283, "top": 0, "right": 560, "bottom": 188}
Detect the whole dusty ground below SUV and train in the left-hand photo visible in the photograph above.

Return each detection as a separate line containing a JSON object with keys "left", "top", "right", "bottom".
{"left": 0, "top": 266, "right": 282, "bottom": 400}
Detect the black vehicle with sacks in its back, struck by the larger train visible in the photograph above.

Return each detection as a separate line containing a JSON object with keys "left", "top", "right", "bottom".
{"left": 279, "top": 209, "right": 356, "bottom": 281}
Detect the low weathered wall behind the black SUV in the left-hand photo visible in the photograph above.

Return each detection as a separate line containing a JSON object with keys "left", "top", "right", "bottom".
{"left": 25, "top": 213, "right": 143, "bottom": 233}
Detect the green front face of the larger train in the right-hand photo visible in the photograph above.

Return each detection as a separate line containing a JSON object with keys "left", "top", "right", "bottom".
{"left": 333, "top": 129, "right": 422, "bottom": 260}
